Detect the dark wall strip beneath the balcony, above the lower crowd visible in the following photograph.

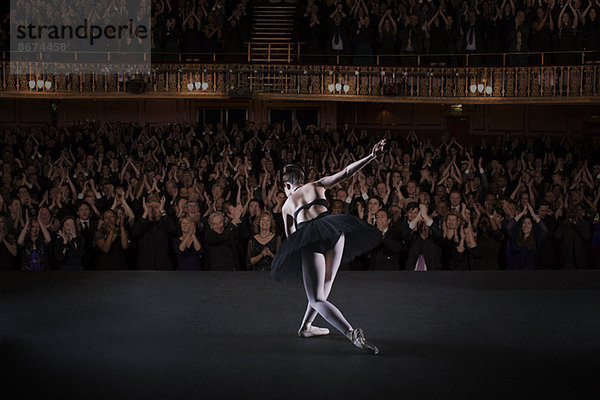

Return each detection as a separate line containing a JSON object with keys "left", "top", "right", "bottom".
{"left": 0, "top": 98, "right": 600, "bottom": 142}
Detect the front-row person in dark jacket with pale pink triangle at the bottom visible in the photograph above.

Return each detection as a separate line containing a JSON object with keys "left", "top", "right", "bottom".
{"left": 401, "top": 204, "right": 442, "bottom": 271}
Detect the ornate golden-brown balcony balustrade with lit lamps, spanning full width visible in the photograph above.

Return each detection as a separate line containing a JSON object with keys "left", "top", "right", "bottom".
{"left": 0, "top": 61, "right": 600, "bottom": 102}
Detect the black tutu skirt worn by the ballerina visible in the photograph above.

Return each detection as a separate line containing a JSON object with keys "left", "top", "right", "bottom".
{"left": 271, "top": 212, "right": 383, "bottom": 281}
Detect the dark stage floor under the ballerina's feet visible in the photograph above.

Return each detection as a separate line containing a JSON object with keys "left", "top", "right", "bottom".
{"left": 0, "top": 271, "right": 600, "bottom": 399}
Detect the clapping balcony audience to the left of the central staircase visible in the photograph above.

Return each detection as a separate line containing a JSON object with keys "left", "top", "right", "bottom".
{"left": 0, "top": 0, "right": 251, "bottom": 62}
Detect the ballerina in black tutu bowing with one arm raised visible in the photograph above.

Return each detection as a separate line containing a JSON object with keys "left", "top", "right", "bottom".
{"left": 271, "top": 140, "right": 385, "bottom": 354}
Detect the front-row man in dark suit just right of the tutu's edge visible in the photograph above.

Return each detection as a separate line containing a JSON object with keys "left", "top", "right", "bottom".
{"left": 369, "top": 209, "right": 402, "bottom": 271}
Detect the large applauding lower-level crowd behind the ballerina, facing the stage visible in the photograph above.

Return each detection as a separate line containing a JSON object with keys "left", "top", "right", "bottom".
{"left": 0, "top": 121, "right": 600, "bottom": 271}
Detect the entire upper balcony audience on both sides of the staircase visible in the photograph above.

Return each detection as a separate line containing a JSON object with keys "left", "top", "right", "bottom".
{"left": 0, "top": 0, "right": 600, "bottom": 66}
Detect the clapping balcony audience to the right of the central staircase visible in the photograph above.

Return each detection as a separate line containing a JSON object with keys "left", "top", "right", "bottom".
{"left": 300, "top": 0, "right": 600, "bottom": 66}
